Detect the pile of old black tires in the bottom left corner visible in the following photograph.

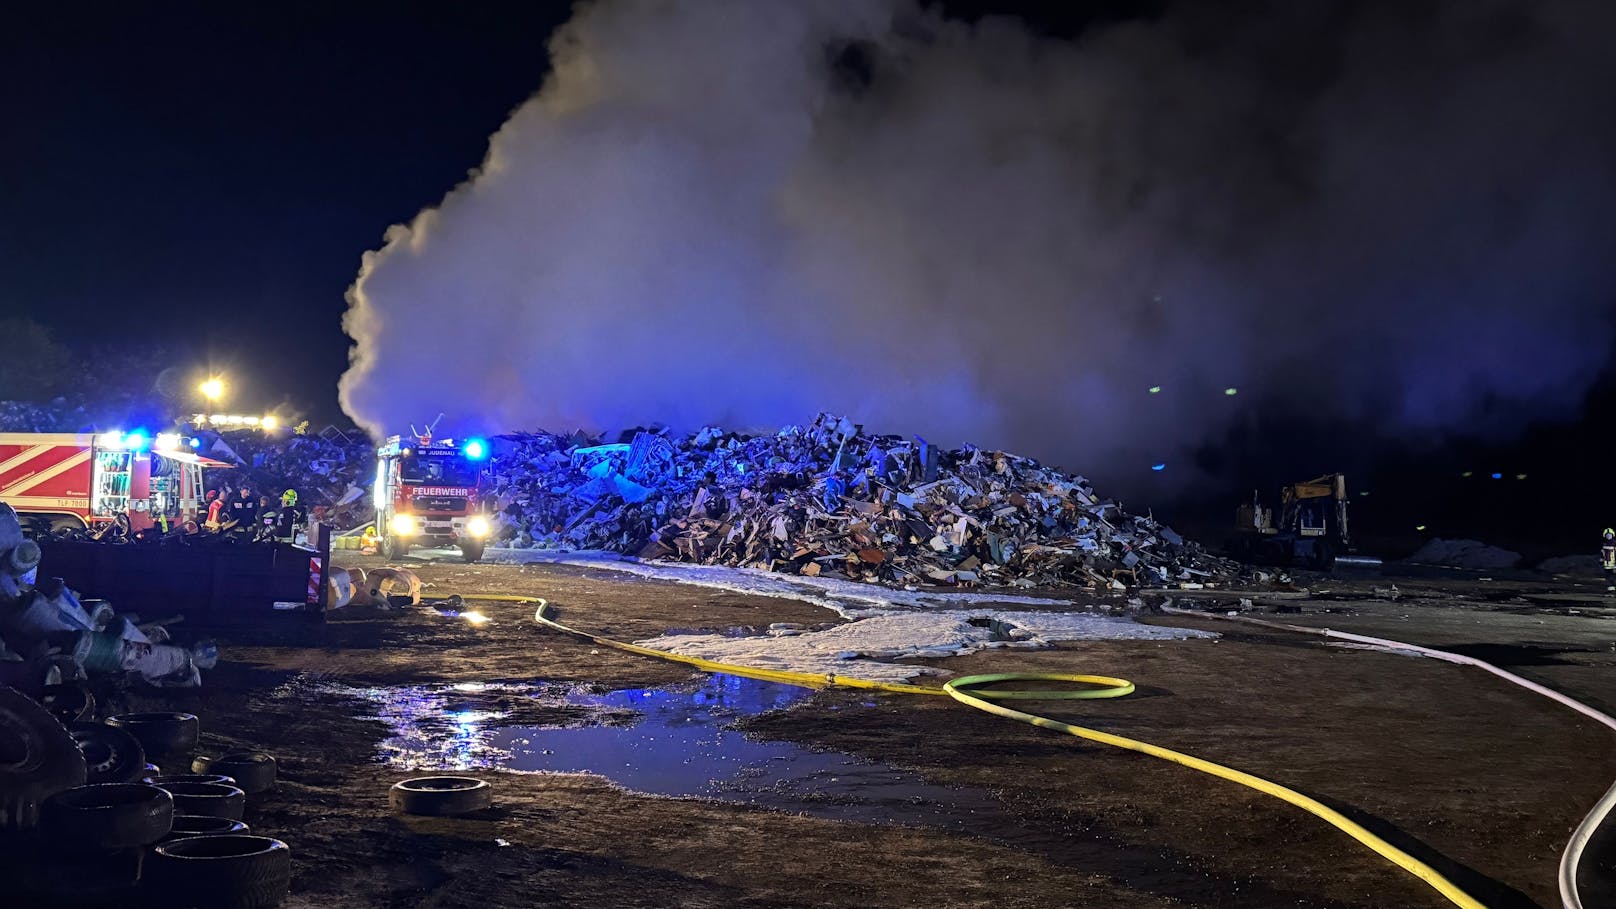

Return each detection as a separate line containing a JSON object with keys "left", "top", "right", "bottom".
{"left": 0, "top": 687, "right": 291, "bottom": 909}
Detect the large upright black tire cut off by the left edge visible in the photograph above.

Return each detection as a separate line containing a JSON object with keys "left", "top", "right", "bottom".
{"left": 0, "top": 687, "right": 86, "bottom": 831}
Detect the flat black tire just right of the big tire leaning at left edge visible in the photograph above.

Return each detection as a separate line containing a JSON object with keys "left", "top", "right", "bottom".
{"left": 40, "top": 783, "right": 175, "bottom": 849}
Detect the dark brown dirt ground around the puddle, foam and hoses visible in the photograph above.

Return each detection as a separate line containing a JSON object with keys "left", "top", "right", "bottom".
{"left": 78, "top": 556, "right": 1616, "bottom": 909}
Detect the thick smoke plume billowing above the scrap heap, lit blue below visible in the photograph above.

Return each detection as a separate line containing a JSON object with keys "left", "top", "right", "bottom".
{"left": 341, "top": 0, "right": 1616, "bottom": 479}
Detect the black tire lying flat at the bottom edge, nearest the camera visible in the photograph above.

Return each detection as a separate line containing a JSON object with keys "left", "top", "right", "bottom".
{"left": 145, "top": 835, "right": 292, "bottom": 909}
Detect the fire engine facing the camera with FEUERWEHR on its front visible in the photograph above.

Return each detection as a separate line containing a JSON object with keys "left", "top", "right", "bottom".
{"left": 372, "top": 430, "right": 493, "bottom": 561}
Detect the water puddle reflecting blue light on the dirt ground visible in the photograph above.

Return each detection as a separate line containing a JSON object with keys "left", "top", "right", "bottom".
{"left": 335, "top": 674, "right": 1004, "bottom": 828}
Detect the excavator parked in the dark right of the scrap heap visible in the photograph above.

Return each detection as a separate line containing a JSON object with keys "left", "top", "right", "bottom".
{"left": 1235, "top": 474, "right": 1380, "bottom": 571}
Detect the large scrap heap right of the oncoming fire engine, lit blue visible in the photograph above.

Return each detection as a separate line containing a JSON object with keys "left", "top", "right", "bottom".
{"left": 493, "top": 414, "right": 1238, "bottom": 587}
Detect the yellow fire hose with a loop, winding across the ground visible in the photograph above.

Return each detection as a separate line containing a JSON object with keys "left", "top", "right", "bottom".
{"left": 481, "top": 597, "right": 1485, "bottom": 909}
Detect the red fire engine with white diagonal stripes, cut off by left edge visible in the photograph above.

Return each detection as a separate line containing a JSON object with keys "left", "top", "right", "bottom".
{"left": 0, "top": 430, "right": 233, "bottom": 532}
